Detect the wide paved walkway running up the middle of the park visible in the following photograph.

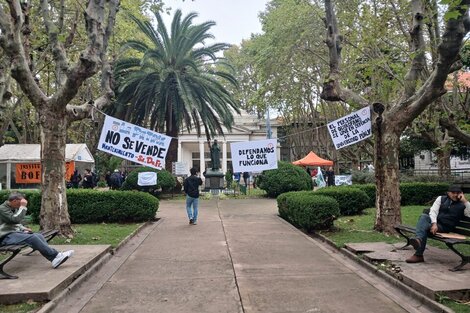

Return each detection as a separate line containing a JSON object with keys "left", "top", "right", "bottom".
{"left": 43, "top": 199, "right": 446, "bottom": 313}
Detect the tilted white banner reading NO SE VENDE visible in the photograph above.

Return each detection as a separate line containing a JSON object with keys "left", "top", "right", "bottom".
{"left": 98, "top": 116, "right": 171, "bottom": 169}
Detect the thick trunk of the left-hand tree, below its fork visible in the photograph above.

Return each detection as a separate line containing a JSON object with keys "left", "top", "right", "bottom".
{"left": 40, "top": 110, "right": 73, "bottom": 238}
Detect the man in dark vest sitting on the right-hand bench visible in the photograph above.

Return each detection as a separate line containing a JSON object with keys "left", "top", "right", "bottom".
{"left": 406, "top": 186, "right": 470, "bottom": 263}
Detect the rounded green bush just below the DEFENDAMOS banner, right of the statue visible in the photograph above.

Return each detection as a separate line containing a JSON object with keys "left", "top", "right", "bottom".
{"left": 257, "top": 161, "right": 312, "bottom": 198}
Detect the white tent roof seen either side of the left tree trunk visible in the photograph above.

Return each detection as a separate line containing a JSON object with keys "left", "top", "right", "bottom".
{"left": 0, "top": 143, "right": 95, "bottom": 163}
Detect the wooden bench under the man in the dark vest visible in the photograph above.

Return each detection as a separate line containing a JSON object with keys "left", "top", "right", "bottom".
{"left": 395, "top": 209, "right": 470, "bottom": 272}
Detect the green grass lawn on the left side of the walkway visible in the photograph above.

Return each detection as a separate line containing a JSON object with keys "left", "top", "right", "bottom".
{"left": 0, "top": 223, "right": 142, "bottom": 313}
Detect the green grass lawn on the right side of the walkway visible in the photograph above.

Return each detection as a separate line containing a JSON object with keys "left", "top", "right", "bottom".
{"left": 319, "top": 206, "right": 470, "bottom": 313}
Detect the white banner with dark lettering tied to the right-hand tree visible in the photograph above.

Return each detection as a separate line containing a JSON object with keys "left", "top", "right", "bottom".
{"left": 328, "top": 107, "right": 372, "bottom": 150}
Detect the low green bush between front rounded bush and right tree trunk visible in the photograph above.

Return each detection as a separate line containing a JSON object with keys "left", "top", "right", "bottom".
{"left": 315, "top": 186, "right": 370, "bottom": 215}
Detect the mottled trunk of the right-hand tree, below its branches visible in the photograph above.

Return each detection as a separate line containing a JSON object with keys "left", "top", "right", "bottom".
{"left": 374, "top": 103, "right": 401, "bottom": 234}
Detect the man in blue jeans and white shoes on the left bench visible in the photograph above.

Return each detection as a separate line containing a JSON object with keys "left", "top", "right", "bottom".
{"left": 0, "top": 192, "right": 74, "bottom": 268}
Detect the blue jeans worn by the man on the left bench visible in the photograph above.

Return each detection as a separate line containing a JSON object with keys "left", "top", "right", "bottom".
{"left": 2, "top": 232, "right": 58, "bottom": 261}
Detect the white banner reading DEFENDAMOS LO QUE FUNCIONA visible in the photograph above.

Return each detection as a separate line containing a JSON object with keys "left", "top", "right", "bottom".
{"left": 230, "top": 139, "right": 277, "bottom": 173}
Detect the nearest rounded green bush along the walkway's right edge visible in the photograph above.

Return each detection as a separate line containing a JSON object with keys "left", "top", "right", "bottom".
{"left": 277, "top": 191, "right": 340, "bottom": 232}
